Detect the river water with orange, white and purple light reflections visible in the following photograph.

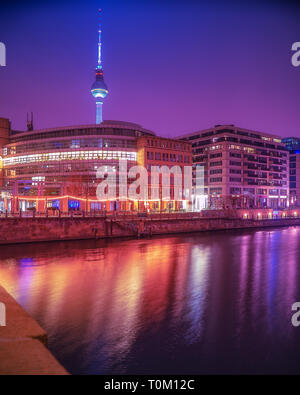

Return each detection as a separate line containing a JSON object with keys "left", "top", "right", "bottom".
{"left": 0, "top": 228, "right": 300, "bottom": 374}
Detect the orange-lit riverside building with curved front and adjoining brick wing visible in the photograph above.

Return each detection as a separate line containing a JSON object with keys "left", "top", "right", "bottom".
{"left": 0, "top": 119, "right": 191, "bottom": 212}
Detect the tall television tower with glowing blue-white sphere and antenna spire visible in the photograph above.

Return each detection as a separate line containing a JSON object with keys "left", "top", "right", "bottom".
{"left": 91, "top": 9, "right": 108, "bottom": 124}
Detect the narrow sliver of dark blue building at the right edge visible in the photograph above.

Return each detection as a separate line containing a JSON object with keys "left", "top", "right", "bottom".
{"left": 282, "top": 137, "right": 300, "bottom": 207}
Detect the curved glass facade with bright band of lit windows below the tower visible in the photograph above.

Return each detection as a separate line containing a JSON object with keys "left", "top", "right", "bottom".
{"left": 2, "top": 122, "right": 154, "bottom": 209}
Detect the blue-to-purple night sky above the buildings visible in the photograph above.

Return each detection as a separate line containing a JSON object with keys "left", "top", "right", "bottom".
{"left": 0, "top": 0, "right": 300, "bottom": 137}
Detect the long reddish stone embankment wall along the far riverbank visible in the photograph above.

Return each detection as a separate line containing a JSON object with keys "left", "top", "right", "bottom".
{"left": 0, "top": 213, "right": 300, "bottom": 244}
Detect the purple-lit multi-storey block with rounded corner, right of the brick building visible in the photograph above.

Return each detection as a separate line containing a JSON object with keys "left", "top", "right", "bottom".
{"left": 181, "top": 125, "right": 289, "bottom": 209}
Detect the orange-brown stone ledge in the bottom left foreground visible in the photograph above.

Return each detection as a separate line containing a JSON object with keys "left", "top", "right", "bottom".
{"left": 0, "top": 286, "right": 68, "bottom": 375}
